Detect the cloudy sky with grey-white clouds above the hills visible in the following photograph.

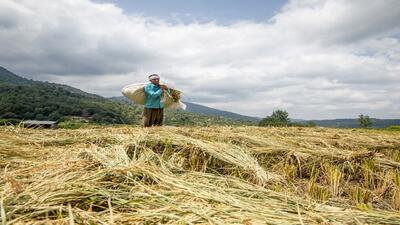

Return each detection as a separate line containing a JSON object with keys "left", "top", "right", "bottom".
{"left": 0, "top": 0, "right": 400, "bottom": 119}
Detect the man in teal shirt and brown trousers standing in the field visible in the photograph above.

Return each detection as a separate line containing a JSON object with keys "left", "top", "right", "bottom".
{"left": 143, "top": 74, "right": 167, "bottom": 127}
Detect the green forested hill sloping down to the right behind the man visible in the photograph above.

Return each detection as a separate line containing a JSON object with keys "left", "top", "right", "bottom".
{"left": 0, "top": 67, "right": 253, "bottom": 125}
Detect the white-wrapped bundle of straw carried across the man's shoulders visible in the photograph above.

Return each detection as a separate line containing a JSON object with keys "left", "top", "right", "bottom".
{"left": 122, "top": 83, "right": 186, "bottom": 110}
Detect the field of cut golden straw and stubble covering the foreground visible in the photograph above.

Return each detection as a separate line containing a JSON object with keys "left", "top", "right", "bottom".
{"left": 0, "top": 126, "right": 400, "bottom": 225}
